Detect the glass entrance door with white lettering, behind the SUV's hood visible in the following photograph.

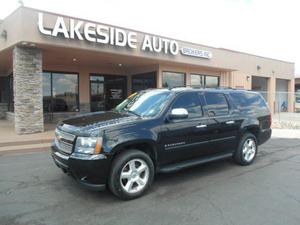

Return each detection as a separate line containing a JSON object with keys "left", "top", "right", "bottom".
{"left": 90, "top": 74, "right": 127, "bottom": 112}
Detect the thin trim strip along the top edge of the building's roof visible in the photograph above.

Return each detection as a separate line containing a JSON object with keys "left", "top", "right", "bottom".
{"left": 0, "top": 6, "right": 295, "bottom": 64}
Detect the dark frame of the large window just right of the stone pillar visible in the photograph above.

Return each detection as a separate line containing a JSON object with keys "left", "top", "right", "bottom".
{"left": 42, "top": 70, "right": 80, "bottom": 113}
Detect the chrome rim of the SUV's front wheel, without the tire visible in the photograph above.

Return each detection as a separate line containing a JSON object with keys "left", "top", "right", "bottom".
{"left": 120, "top": 159, "right": 149, "bottom": 194}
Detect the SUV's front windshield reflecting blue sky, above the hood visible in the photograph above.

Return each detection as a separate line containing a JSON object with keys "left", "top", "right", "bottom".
{"left": 115, "top": 90, "right": 171, "bottom": 117}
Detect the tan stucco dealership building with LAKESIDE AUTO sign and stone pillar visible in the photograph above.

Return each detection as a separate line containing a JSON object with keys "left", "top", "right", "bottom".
{"left": 0, "top": 7, "right": 295, "bottom": 134}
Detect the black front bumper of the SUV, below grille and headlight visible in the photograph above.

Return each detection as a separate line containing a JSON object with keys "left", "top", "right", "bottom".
{"left": 51, "top": 142, "right": 111, "bottom": 190}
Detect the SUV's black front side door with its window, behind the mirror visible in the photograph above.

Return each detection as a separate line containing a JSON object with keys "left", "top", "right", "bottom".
{"left": 159, "top": 92, "right": 209, "bottom": 165}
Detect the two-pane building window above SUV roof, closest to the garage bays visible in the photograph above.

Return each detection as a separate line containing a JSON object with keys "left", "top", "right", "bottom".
{"left": 191, "top": 74, "right": 220, "bottom": 88}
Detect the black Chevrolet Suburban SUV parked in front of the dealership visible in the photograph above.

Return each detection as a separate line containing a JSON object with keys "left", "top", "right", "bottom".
{"left": 52, "top": 88, "right": 271, "bottom": 199}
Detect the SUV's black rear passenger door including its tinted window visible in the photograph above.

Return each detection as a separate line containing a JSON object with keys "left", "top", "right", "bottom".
{"left": 204, "top": 92, "right": 239, "bottom": 154}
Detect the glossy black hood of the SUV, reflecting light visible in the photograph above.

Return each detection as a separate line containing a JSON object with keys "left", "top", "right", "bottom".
{"left": 59, "top": 111, "right": 138, "bottom": 133}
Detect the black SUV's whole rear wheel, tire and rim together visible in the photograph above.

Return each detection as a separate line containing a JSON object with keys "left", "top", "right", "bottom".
{"left": 233, "top": 133, "right": 258, "bottom": 166}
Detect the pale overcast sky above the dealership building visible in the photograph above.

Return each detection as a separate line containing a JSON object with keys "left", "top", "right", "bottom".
{"left": 0, "top": 0, "right": 300, "bottom": 74}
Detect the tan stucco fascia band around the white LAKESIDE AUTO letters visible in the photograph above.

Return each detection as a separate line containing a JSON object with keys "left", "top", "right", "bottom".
{"left": 0, "top": 8, "right": 294, "bottom": 79}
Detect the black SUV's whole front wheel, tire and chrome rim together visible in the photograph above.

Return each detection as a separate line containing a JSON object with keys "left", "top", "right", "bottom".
{"left": 108, "top": 149, "right": 154, "bottom": 200}
